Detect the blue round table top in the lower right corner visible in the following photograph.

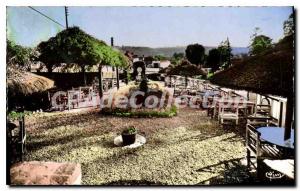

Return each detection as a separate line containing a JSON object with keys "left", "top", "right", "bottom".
{"left": 257, "top": 127, "right": 294, "bottom": 149}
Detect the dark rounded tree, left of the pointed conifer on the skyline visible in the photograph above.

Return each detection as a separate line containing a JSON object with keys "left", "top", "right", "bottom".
{"left": 185, "top": 44, "right": 205, "bottom": 65}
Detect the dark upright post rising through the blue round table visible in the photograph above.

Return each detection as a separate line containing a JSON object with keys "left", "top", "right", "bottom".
{"left": 284, "top": 95, "right": 294, "bottom": 140}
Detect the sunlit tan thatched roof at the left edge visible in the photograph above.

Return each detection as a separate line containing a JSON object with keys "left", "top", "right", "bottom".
{"left": 6, "top": 67, "right": 54, "bottom": 95}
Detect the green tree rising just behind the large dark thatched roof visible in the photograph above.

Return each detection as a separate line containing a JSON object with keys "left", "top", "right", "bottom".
{"left": 249, "top": 27, "right": 272, "bottom": 55}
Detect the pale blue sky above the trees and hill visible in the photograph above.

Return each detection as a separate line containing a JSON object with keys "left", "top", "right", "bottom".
{"left": 7, "top": 7, "right": 293, "bottom": 47}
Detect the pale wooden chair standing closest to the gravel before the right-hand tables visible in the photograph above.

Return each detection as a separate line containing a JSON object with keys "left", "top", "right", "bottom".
{"left": 218, "top": 105, "right": 239, "bottom": 125}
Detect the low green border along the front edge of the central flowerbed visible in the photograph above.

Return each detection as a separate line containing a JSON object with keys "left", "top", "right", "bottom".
{"left": 102, "top": 105, "right": 177, "bottom": 118}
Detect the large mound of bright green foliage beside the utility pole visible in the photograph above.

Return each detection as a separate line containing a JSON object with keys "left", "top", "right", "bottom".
{"left": 38, "top": 27, "right": 128, "bottom": 70}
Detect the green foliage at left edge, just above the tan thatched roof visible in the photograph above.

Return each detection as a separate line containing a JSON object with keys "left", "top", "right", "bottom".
{"left": 6, "top": 40, "right": 34, "bottom": 70}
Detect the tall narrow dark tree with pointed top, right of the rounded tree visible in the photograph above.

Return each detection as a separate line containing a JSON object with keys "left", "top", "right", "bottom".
{"left": 218, "top": 38, "right": 233, "bottom": 68}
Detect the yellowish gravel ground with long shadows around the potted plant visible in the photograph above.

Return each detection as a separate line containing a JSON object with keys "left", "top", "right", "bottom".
{"left": 26, "top": 109, "right": 249, "bottom": 185}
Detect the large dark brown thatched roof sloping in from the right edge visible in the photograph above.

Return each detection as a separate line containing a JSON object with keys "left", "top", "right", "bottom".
{"left": 210, "top": 37, "right": 294, "bottom": 97}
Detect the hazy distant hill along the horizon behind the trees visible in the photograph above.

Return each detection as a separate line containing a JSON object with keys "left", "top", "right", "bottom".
{"left": 117, "top": 46, "right": 249, "bottom": 57}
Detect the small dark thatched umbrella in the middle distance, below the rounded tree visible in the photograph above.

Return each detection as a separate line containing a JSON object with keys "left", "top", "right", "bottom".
{"left": 164, "top": 60, "right": 206, "bottom": 86}
